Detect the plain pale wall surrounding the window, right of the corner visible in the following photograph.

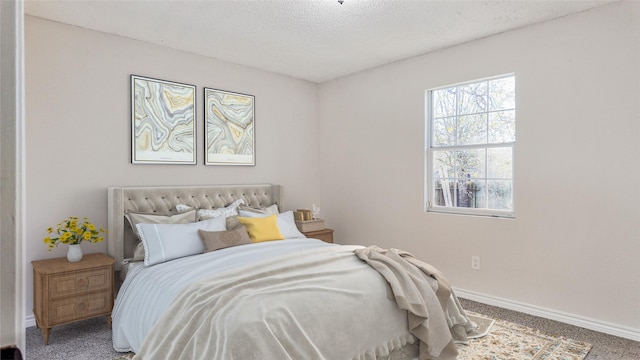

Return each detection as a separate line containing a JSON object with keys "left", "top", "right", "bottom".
{"left": 320, "top": 2, "right": 640, "bottom": 337}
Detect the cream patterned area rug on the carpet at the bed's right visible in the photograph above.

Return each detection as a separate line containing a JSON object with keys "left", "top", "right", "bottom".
{"left": 113, "top": 311, "right": 591, "bottom": 360}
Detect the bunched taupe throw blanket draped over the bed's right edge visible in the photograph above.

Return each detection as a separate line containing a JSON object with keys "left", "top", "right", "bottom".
{"left": 355, "top": 246, "right": 475, "bottom": 360}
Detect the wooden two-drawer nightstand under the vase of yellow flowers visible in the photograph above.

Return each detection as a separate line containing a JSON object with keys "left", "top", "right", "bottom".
{"left": 31, "top": 253, "right": 115, "bottom": 345}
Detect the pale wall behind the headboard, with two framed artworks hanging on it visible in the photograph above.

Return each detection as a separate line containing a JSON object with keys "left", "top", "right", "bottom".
{"left": 25, "top": 16, "right": 320, "bottom": 322}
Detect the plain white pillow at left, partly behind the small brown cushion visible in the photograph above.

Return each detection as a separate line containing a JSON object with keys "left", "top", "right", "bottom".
{"left": 136, "top": 217, "right": 227, "bottom": 266}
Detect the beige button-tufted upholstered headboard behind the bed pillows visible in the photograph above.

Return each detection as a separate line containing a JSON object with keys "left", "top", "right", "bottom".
{"left": 108, "top": 184, "right": 283, "bottom": 270}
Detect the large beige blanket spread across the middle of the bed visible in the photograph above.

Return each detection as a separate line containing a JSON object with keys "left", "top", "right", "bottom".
{"left": 135, "top": 246, "right": 416, "bottom": 360}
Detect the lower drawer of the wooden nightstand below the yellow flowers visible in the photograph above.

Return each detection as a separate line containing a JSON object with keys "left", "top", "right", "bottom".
{"left": 49, "top": 290, "right": 113, "bottom": 324}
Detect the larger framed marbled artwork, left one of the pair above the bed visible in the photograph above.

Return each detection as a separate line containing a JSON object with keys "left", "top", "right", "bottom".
{"left": 131, "top": 75, "right": 196, "bottom": 164}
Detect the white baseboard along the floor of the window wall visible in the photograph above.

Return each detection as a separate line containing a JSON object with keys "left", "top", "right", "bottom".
{"left": 453, "top": 287, "right": 640, "bottom": 341}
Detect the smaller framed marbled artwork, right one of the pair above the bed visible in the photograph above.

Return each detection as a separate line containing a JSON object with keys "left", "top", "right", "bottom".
{"left": 204, "top": 88, "right": 256, "bottom": 166}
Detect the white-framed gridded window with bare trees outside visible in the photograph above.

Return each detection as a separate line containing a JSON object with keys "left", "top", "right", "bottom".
{"left": 425, "top": 74, "right": 516, "bottom": 217}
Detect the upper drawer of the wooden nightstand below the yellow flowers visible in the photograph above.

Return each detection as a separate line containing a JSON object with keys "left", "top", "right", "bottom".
{"left": 49, "top": 267, "right": 112, "bottom": 299}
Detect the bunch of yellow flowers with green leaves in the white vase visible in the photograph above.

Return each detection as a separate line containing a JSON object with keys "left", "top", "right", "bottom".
{"left": 43, "top": 216, "right": 107, "bottom": 251}
